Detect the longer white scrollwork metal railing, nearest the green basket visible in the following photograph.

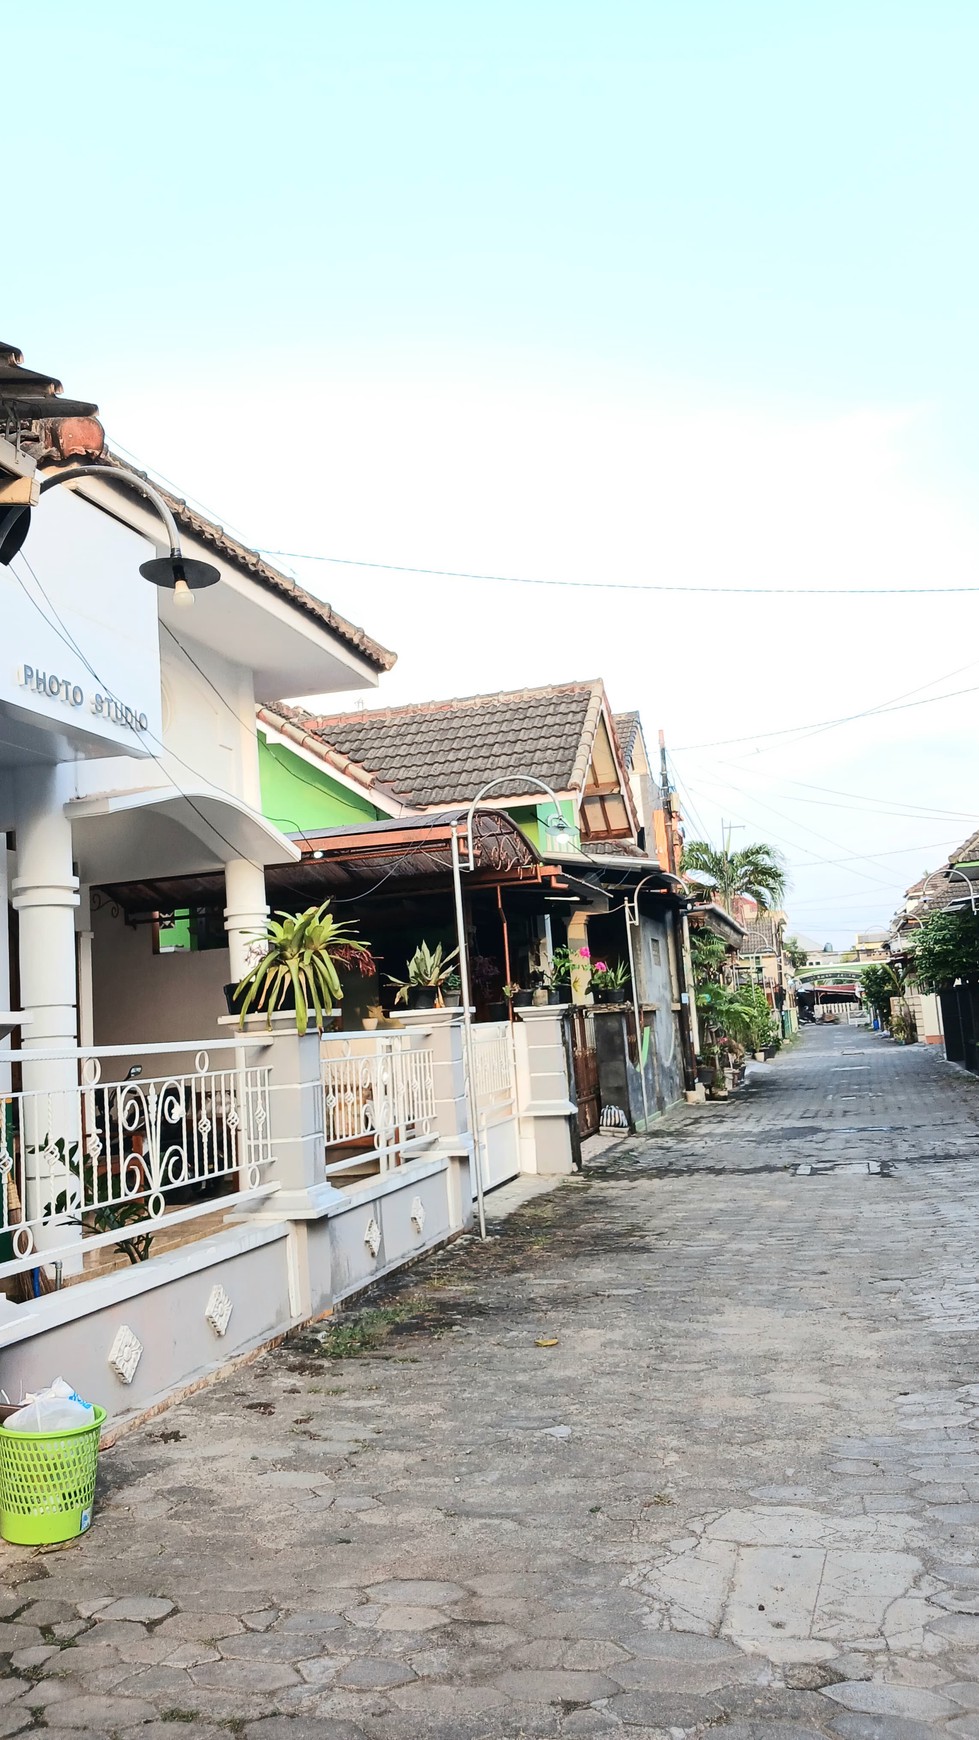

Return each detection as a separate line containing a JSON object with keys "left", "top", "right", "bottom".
{"left": 0, "top": 1037, "right": 275, "bottom": 1277}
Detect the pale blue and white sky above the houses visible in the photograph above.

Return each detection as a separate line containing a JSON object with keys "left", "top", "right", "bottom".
{"left": 3, "top": 0, "right": 979, "bottom": 945}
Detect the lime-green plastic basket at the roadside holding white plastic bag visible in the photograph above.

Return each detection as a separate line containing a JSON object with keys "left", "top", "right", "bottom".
{"left": 0, "top": 1408, "right": 106, "bottom": 1547}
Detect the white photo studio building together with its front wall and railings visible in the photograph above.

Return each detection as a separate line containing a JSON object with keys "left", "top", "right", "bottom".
{"left": 0, "top": 346, "right": 574, "bottom": 1418}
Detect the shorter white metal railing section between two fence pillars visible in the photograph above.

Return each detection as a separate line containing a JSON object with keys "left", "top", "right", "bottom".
{"left": 320, "top": 1032, "right": 436, "bottom": 1178}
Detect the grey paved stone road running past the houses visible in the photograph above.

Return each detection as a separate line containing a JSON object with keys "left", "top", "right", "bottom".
{"left": 0, "top": 1028, "right": 979, "bottom": 1740}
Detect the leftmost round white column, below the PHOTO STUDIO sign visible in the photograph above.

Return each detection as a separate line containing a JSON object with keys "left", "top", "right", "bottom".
{"left": 12, "top": 767, "right": 82, "bottom": 1249}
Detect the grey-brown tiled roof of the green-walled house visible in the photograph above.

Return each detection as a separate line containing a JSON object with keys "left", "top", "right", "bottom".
{"left": 271, "top": 682, "right": 603, "bottom": 807}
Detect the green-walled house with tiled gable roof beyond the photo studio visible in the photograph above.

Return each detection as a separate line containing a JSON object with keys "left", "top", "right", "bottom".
{"left": 257, "top": 680, "right": 705, "bottom": 1122}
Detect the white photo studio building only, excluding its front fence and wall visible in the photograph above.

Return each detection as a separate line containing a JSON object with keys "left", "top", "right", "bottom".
{"left": 0, "top": 388, "right": 393, "bottom": 1078}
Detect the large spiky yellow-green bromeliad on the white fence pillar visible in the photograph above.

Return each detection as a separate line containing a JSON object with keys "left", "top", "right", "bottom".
{"left": 235, "top": 900, "right": 370, "bottom": 1034}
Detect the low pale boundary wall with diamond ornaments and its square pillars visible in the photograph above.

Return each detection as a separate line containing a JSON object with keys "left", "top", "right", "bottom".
{"left": 0, "top": 1009, "right": 574, "bottom": 1434}
